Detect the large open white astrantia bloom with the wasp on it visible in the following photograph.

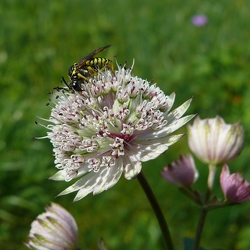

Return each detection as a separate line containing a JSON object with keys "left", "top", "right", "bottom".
{"left": 47, "top": 64, "right": 193, "bottom": 201}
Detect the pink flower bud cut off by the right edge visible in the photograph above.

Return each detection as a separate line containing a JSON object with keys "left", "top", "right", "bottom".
{"left": 220, "top": 164, "right": 250, "bottom": 202}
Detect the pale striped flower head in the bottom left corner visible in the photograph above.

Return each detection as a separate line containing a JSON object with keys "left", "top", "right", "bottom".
{"left": 26, "top": 203, "right": 78, "bottom": 250}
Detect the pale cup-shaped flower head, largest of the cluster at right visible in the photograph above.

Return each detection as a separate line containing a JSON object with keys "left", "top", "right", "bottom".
{"left": 188, "top": 116, "right": 244, "bottom": 165}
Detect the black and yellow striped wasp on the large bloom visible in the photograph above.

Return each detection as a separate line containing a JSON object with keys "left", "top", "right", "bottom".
{"left": 62, "top": 45, "right": 114, "bottom": 92}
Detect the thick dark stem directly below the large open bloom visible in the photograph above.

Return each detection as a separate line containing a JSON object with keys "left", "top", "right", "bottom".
{"left": 137, "top": 172, "right": 174, "bottom": 250}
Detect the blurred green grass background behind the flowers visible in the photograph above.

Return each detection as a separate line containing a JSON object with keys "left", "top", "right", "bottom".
{"left": 0, "top": 0, "right": 250, "bottom": 250}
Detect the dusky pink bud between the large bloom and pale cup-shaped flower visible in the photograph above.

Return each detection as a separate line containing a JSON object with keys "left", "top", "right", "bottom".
{"left": 161, "top": 154, "right": 199, "bottom": 187}
